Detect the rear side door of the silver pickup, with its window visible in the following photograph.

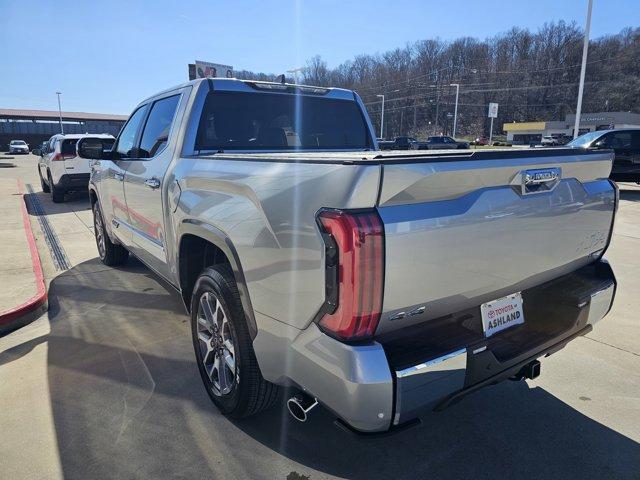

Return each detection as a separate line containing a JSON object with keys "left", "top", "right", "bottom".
{"left": 124, "top": 93, "right": 181, "bottom": 279}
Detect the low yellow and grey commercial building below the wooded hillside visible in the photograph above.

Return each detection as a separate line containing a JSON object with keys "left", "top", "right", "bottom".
{"left": 503, "top": 112, "right": 640, "bottom": 144}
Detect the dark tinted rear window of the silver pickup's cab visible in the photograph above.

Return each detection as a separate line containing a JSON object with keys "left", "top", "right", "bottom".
{"left": 195, "top": 92, "right": 371, "bottom": 150}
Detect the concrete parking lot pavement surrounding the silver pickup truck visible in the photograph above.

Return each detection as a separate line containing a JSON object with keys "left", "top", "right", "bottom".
{"left": 0, "top": 156, "right": 640, "bottom": 480}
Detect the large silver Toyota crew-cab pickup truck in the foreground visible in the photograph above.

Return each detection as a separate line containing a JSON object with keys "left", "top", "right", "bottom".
{"left": 77, "top": 79, "right": 618, "bottom": 433}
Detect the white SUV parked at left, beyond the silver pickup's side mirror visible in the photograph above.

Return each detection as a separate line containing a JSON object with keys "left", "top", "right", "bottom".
{"left": 38, "top": 134, "right": 115, "bottom": 203}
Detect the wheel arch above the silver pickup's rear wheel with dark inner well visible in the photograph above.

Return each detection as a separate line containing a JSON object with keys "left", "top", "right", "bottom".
{"left": 176, "top": 219, "right": 258, "bottom": 339}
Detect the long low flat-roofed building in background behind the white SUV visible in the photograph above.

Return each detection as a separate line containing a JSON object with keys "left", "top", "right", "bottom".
{"left": 0, "top": 108, "right": 127, "bottom": 150}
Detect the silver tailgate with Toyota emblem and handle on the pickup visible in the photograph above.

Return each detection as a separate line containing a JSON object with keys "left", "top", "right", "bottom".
{"left": 377, "top": 149, "right": 616, "bottom": 334}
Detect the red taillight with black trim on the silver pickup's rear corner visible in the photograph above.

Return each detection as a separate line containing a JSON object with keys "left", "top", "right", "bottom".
{"left": 318, "top": 210, "right": 384, "bottom": 340}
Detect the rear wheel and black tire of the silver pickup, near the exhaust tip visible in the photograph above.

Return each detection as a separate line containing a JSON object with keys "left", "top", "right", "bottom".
{"left": 191, "top": 265, "right": 280, "bottom": 418}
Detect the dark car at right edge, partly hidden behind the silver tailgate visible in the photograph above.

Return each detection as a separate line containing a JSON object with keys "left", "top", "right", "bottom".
{"left": 567, "top": 129, "right": 640, "bottom": 184}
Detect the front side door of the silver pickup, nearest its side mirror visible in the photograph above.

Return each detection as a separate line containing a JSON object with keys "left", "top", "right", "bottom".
{"left": 97, "top": 105, "right": 147, "bottom": 247}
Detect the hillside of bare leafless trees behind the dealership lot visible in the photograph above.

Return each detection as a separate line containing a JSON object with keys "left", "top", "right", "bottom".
{"left": 237, "top": 21, "right": 640, "bottom": 138}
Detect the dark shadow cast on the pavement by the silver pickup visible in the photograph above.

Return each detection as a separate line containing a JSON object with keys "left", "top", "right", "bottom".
{"left": 0, "top": 259, "right": 640, "bottom": 479}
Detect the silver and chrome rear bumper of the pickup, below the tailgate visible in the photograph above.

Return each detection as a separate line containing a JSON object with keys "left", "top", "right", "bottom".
{"left": 254, "top": 261, "right": 616, "bottom": 433}
